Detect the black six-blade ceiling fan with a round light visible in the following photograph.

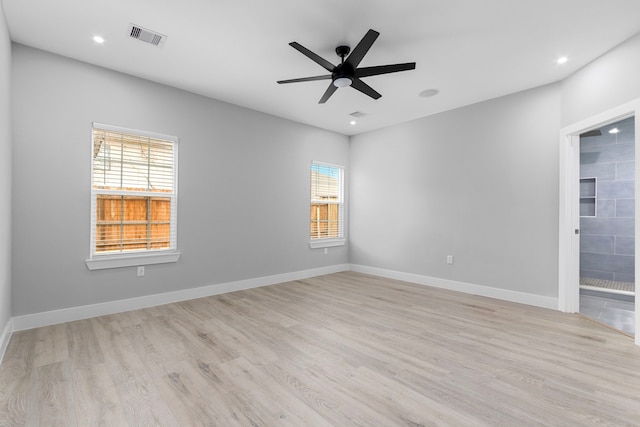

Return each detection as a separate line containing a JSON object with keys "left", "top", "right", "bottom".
{"left": 278, "top": 30, "right": 416, "bottom": 104}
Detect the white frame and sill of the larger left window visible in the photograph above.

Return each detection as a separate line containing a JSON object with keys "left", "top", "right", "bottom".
{"left": 85, "top": 122, "right": 180, "bottom": 270}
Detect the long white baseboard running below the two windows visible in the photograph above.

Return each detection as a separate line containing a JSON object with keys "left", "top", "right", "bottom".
{"left": 10, "top": 264, "right": 349, "bottom": 334}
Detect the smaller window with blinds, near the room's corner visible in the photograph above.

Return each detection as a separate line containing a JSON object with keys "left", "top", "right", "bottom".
{"left": 310, "top": 162, "right": 345, "bottom": 248}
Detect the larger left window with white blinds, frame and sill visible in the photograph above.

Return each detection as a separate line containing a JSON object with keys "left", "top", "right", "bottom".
{"left": 87, "top": 123, "right": 180, "bottom": 270}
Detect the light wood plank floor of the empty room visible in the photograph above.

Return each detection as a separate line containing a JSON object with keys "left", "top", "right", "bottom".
{"left": 0, "top": 272, "right": 640, "bottom": 427}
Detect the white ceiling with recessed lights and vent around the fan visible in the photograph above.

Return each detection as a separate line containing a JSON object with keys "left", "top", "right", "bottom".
{"left": 3, "top": 0, "right": 640, "bottom": 135}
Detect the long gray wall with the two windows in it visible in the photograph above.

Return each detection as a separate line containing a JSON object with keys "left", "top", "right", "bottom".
{"left": 12, "top": 44, "right": 349, "bottom": 316}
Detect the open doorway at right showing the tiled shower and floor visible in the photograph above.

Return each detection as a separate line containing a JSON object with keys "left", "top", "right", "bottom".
{"left": 579, "top": 116, "right": 635, "bottom": 336}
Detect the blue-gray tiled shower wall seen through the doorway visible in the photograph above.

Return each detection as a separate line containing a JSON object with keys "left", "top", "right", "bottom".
{"left": 580, "top": 117, "right": 635, "bottom": 282}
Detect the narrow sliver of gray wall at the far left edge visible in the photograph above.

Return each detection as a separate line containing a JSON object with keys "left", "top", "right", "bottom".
{"left": 0, "top": 5, "right": 11, "bottom": 335}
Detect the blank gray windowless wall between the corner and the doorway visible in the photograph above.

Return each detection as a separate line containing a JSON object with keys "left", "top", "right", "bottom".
{"left": 350, "top": 84, "right": 561, "bottom": 297}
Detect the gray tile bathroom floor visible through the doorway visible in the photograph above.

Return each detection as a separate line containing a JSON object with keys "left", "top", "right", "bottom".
{"left": 580, "top": 289, "right": 635, "bottom": 335}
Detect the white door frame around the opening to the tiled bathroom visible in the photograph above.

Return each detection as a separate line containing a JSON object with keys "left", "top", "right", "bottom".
{"left": 558, "top": 99, "right": 640, "bottom": 346}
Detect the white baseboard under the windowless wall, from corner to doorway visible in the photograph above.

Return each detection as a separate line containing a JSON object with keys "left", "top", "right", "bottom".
{"left": 349, "top": 264, "right": 558, "bottom": 310}
